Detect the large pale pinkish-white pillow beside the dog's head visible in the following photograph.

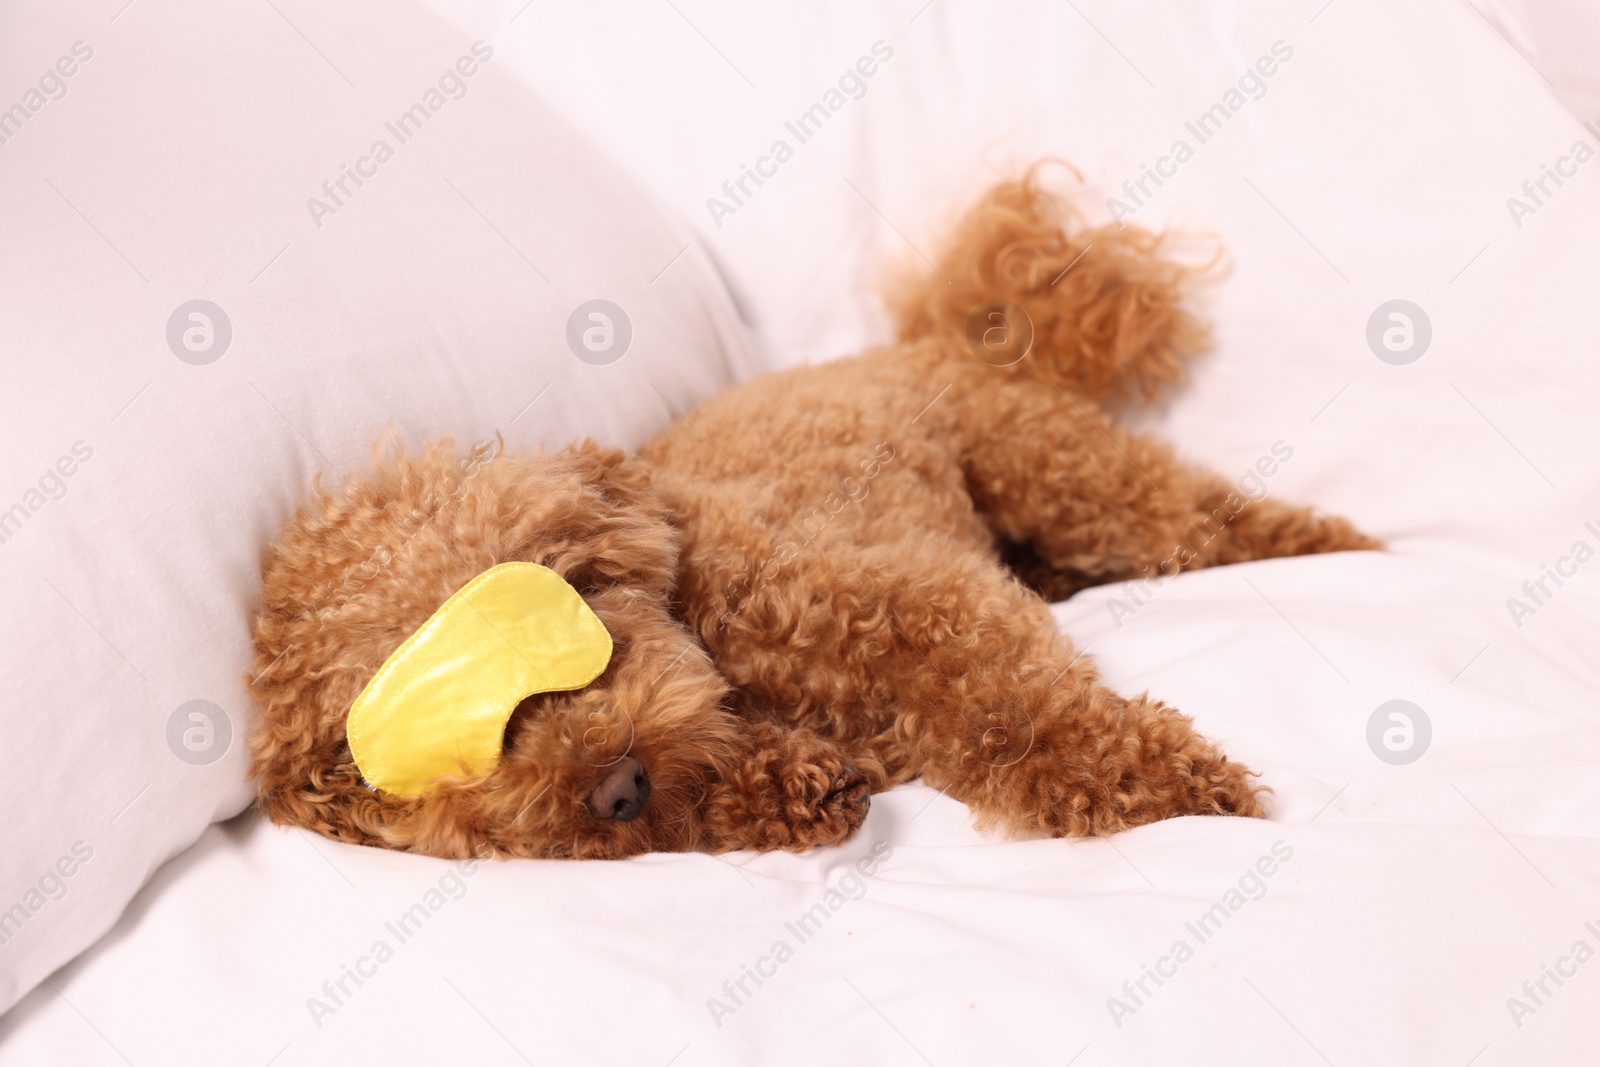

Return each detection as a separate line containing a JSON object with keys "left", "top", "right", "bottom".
{"left": 0, "top": 0, "right": 758, "bottom": 1009}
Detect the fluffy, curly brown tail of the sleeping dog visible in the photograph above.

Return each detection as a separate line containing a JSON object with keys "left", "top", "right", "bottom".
{"left": 888, "top": 163, "right": 1214, "bottom": 400}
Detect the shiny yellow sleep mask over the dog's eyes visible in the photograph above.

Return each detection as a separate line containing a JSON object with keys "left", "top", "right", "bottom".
{"left": 344, "top": 563, "right": 611, "bottom": 797}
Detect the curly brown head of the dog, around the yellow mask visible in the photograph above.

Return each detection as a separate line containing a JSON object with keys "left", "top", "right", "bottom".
{"left": 251, "top": 442, "right": 728, "bottom": 857}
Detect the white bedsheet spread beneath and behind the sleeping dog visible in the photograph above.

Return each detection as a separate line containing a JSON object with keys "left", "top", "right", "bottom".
{"left": 0, "top": 0, "right": 1600, "bottom": 1067}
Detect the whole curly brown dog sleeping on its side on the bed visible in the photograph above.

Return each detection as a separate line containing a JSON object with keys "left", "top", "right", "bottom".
{"left": 251, "top": 168, "right": 1379, "bottom": 857}
